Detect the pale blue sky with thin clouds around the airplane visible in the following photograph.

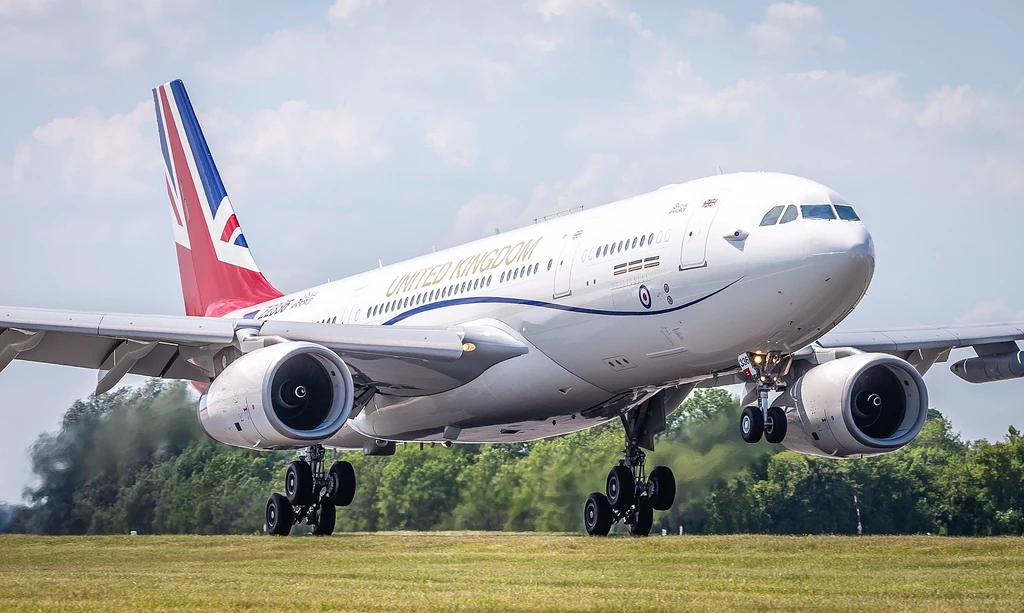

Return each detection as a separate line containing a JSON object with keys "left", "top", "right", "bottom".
{"left": 0, "top": 0, "right": 1024, "bottom": 501}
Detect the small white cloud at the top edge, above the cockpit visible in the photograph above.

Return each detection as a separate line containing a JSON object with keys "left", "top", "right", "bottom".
{"left": 746, "top": 1, "right": 846, "bottom": 55}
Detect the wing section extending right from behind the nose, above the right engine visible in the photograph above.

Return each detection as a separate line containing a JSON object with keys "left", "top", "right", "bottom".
{"left": 811, "top": 321, "right": 1024, "bottom": 374}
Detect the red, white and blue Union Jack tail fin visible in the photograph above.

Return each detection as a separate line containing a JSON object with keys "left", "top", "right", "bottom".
{"left": 153, "top": 80, "right": 282, "bottom": 317}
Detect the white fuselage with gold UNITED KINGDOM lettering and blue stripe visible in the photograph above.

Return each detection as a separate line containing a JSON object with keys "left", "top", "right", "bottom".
{"left": 228, "top": 173, "right": 874, "bottom": 447}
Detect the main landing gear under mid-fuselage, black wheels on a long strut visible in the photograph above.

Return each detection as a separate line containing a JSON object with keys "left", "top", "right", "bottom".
{"left": 583, "top": 396, "right": 676, "bottom": 536}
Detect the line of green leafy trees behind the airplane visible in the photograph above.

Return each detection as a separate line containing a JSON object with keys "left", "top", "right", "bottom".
{"left": 0, "top": 381, "right": 1024, "bottom": 535}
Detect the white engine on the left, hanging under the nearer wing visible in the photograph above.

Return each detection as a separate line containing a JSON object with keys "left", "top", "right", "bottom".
{"left": 199, "top": 342, "right": 353, "bottom": 449}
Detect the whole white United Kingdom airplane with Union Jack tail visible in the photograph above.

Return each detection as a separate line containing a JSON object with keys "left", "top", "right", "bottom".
{"left": 0, "top": 80, "right": 1024, "bottom": 536}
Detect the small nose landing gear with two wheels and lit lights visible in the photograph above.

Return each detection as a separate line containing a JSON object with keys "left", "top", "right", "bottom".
{"left": 738, "top": 351, "right": 792, "bottom": 443}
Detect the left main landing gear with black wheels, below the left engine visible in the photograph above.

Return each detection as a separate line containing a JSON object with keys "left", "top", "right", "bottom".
{"left": 266, "top": 445, "right": 355, "bottom": 536}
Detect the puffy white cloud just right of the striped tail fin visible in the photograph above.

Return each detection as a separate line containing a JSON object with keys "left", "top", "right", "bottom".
{"left": 230, "top": 100, "right": 390, "bottom": 170}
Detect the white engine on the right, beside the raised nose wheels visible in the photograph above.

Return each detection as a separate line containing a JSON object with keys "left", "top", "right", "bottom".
{"left": 776, "top": 353, "right": 928, "bottom": 457}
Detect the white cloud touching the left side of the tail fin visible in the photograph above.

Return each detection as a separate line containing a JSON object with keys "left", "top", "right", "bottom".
{"left": 22, "top": 101, "right": 159, "bottom": 195}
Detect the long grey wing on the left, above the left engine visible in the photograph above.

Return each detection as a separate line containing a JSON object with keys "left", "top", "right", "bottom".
{"left": 0, "top": 307, "right": 527, "bottom": 396}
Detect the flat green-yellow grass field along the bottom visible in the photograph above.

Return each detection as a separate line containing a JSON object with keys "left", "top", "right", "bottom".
{"left": 0, "top": 533, "right": 1024, "bottom": 612}
